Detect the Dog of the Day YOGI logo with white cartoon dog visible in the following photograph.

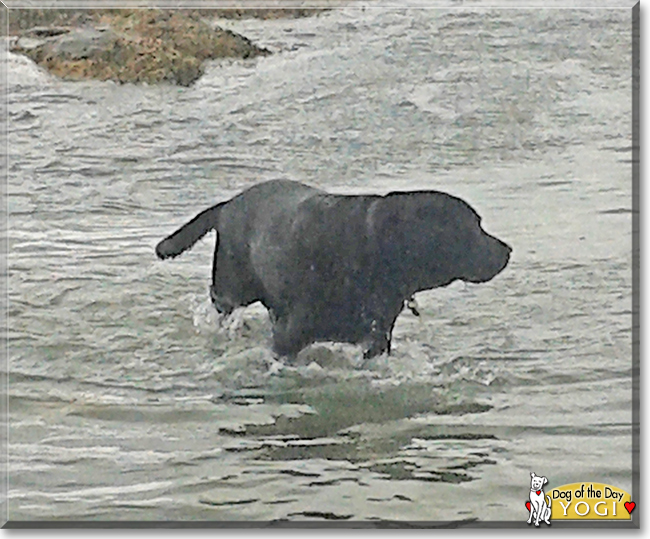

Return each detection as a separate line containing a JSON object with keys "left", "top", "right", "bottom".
{"left": 526, "top": 472, "right": 636, "bottom": 526}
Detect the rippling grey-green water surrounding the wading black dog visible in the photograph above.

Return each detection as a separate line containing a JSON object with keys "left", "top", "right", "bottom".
{"left": 8, "top": 8, "right": 632, "bottom": 522}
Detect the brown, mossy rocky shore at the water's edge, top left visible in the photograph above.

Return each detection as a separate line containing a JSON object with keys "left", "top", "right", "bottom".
{"left": 10, "top": 9, "right": 321, "bottom": 86}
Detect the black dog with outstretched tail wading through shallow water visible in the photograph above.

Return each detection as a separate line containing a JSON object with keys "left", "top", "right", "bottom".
{"left": 156, "top": 180, "right": 511, "bottom": 357}
